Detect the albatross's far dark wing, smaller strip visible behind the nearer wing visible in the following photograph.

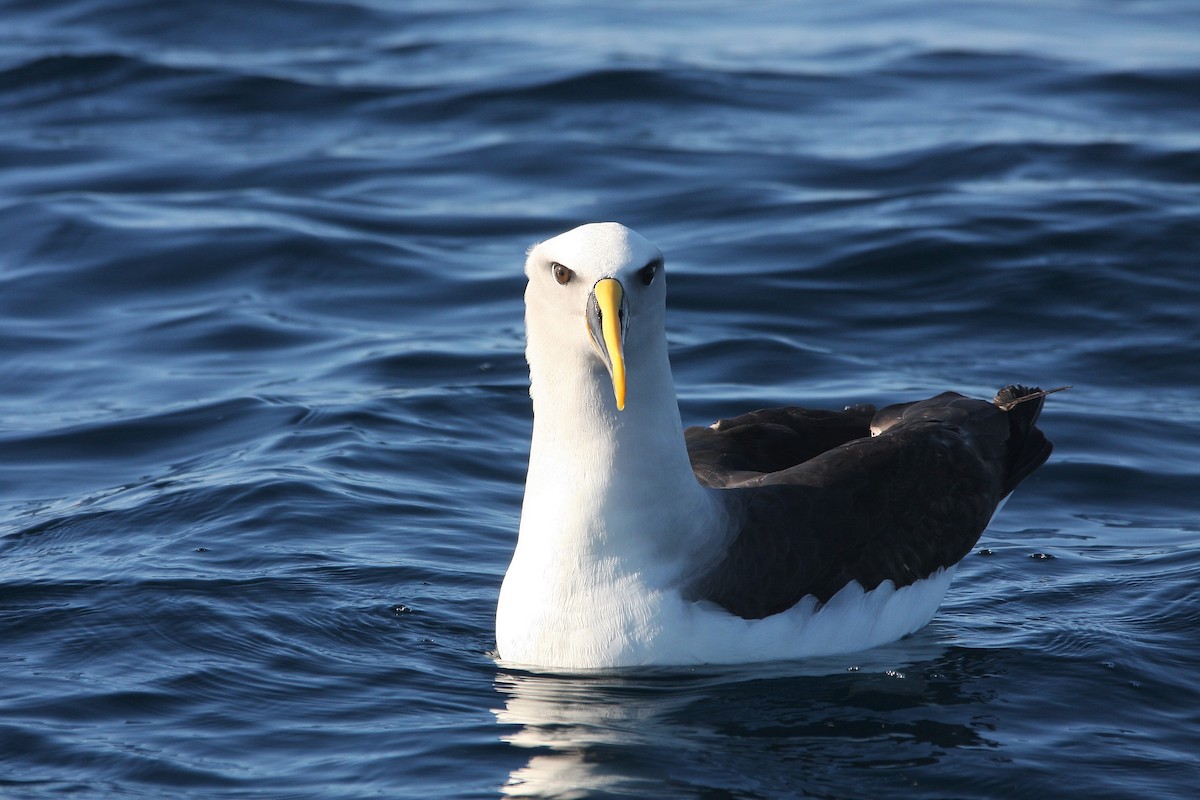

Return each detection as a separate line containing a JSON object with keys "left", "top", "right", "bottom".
{"left": 683, "top": 405, "right": 875, "bottom": 488}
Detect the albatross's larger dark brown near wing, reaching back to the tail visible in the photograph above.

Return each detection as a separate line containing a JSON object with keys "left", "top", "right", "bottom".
{"left": 691, "top": 387, "right": 1050, "bottom": 619}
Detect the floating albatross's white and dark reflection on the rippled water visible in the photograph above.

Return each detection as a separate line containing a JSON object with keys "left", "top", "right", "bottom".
{"left": 496, "top": 639, "right": 994, "bottom": 798}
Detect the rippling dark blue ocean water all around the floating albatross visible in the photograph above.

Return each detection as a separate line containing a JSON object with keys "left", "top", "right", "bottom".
{"left": 0, "top": 0, "right": 1200, "bottom": 800}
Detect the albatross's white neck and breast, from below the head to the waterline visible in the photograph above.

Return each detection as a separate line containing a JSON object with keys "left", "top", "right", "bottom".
{"left": 496, "top": 329, "right": 724, "bottom": 666}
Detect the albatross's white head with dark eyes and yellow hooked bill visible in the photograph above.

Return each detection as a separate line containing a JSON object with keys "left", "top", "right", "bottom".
{"left": 526, "top": 222, "right": 666, "bottom": 410}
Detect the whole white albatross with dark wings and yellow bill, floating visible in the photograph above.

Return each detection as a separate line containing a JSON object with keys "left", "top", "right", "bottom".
{"left": 496, "top": 223, "right": 1057, "bottom": 669}
